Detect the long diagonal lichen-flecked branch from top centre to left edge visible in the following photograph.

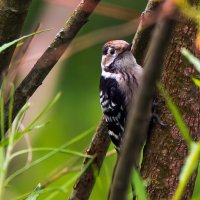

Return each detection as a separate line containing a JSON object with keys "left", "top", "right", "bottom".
{"left": 1, "top": 0, "right": 100, "bottom": 137}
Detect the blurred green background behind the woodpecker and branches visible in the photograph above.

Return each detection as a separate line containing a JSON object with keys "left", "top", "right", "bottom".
{"left": 0, "top": 0, "right": 200, "bottom": 200}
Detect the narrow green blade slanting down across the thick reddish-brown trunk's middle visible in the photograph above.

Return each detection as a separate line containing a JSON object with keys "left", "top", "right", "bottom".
{"left": 157, "top": 83, "right": 193, "bottom": 146}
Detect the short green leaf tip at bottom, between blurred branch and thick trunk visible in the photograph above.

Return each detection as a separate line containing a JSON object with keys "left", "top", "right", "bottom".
{"left": 132, "top": 169, "right": 147, "bottom": 200}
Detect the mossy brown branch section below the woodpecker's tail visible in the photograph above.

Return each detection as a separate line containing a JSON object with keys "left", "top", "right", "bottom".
{"left": 69, "top": 119, "right": 110, "bottom": 200}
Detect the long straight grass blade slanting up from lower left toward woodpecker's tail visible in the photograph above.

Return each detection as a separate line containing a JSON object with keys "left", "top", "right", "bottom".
{"left": 5, "top": 127, "right": 95, "bottom": 185}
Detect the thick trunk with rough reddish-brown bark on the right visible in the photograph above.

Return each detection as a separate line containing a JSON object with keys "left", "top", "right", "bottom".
{"left": 142, "top": 10, "right": 200, "bottom": 200}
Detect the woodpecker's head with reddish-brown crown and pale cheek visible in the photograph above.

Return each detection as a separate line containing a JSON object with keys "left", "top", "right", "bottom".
{"left": 101, "top": 40, "right": 136, "bottom": 73}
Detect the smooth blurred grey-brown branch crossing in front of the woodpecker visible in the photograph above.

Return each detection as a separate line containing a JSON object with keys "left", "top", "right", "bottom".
{"left": 110, "top": 16, "right": 173, "bottom": 200}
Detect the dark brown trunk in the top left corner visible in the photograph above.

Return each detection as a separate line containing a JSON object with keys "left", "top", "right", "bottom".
{"left": 0, "top": 0, "right": 31, "bottom": 83}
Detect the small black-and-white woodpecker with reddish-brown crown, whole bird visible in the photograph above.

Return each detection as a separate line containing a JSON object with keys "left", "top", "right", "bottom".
{"left": 100, "top": 40, "right": 143, "bottom": 150}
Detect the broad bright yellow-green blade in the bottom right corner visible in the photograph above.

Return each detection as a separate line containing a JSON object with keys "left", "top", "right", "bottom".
{"left": 173, "top": 142, "right": 200, "bottom": 200}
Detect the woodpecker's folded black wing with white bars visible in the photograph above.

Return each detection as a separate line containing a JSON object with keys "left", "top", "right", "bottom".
{"left": 100, "top": 76, "right": 127, "bottom": 147}
